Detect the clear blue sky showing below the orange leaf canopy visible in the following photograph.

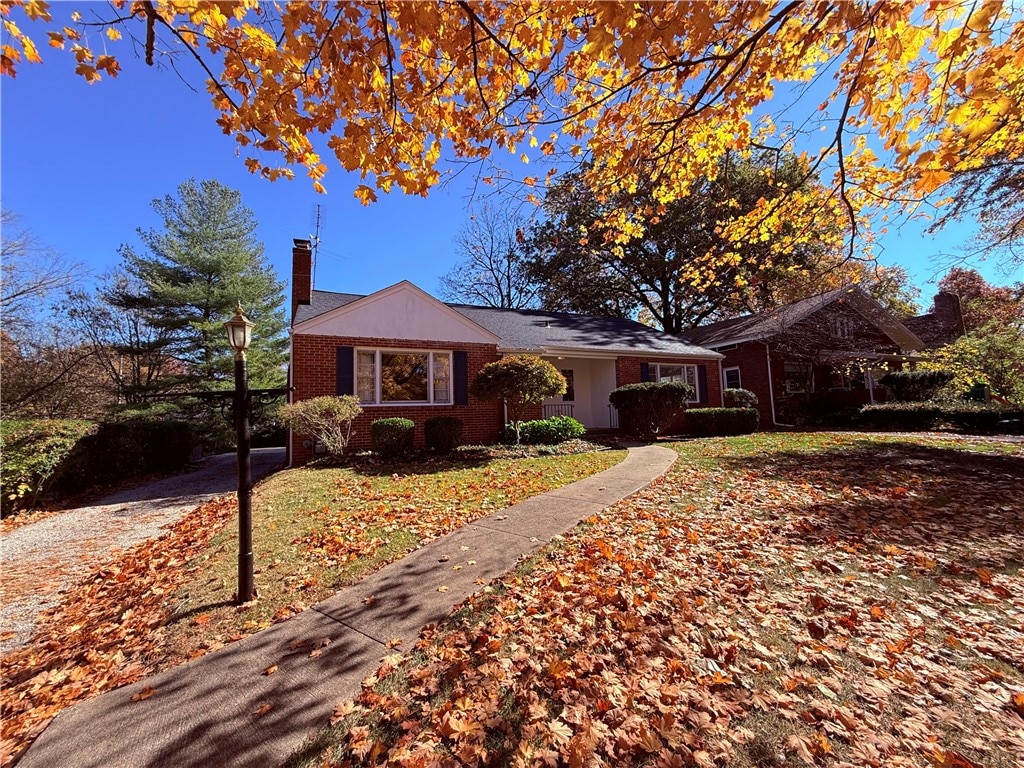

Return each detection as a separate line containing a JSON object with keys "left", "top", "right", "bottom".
{"left": 0, "top": 21, "right": 1024, "bottom": 315}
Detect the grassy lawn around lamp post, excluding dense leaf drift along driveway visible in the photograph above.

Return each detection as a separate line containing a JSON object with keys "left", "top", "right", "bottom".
{"left": 161, "top": 451, "right": 626, "bottom": 662}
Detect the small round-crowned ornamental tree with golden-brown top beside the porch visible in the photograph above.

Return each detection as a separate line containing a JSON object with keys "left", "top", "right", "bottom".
{"left": 471, "top": 354, "right": 565, "bottom": 443}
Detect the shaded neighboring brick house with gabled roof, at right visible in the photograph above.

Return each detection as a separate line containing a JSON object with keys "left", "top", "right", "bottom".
{"left": 683, "top": 286, "right": 964, "bottom": 427}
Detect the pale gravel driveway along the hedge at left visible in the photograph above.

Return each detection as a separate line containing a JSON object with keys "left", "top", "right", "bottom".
{"left": 0, "top": 449, "right": 285, "bottom": 653}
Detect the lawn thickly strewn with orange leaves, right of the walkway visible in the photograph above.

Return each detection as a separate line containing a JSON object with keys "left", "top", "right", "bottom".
{"left": 303, "top": 434, "right": 1024, "bottom": 768}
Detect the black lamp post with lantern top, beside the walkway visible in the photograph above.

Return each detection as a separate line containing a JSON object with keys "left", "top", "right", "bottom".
{"left": 224, "top": 303, "right": 256, "bottom": 605}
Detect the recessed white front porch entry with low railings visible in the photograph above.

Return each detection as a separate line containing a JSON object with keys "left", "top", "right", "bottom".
{"left": 542, "top": 355, "right": 618, "bottom": 429}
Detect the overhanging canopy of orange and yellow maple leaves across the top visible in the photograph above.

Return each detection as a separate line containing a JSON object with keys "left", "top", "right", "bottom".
{"left": 0, "top": 0, "right": 1024, "bottom": 256}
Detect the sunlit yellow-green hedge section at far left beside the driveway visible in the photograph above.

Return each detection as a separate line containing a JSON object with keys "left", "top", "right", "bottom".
{"left": 0, "top": 419, "right": 96, "bottom": 514}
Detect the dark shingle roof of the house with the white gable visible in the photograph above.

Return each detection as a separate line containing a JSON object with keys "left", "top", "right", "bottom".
{"left": 295, "top": 291, "right": 720, "bottom": 357}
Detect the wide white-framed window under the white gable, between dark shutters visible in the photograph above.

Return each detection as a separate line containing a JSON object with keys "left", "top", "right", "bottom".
{"left": 355, "top": 349, "right": 452, "bottom": 406}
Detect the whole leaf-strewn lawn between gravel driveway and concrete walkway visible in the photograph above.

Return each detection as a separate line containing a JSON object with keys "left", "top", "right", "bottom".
{"left": 0, "top": 451, "right": 625, "bottom": 765}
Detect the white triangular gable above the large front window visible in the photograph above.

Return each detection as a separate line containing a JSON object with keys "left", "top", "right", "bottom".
{"left": 293, "top": 281, "right": 499, "bottom": 344}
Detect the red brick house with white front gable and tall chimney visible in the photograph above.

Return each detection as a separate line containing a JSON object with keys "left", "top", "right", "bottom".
{"left": 289, "top": 240, "right": 722, "bottom": 464}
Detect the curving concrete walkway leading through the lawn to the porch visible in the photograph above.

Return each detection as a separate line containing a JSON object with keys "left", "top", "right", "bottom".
{"left": 18, "top": 445, "right": 676, "bottom": 768}
